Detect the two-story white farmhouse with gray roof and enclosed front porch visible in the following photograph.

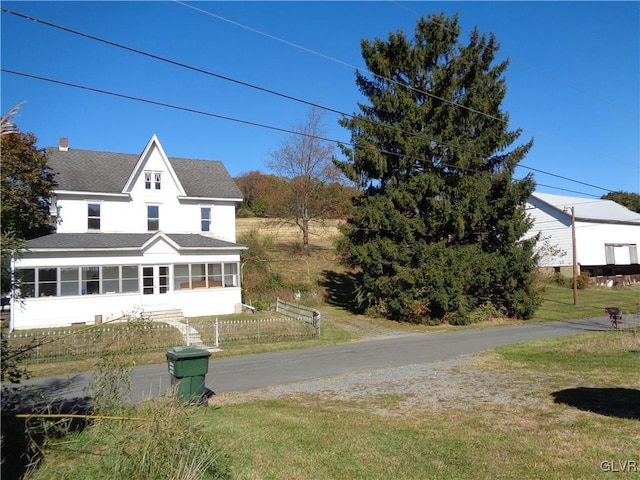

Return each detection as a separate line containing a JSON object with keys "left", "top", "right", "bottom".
{"left": 10, "top": 135, "right": 245, "bottom": 329}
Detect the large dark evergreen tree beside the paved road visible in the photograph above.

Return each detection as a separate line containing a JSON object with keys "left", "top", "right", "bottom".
{"left": 336, "top": 15, "right": 537, "bottom": 322}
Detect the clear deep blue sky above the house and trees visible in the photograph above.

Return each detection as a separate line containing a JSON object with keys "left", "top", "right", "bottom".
{"left": 0, "top": 1, "right": 640, "bottom": 196}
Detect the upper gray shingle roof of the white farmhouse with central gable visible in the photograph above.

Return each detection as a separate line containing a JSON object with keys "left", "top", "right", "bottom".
{"left": 47, "top": 135, "right": 242, "bottom": 201}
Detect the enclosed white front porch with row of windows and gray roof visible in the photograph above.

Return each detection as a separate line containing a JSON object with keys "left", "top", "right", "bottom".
{"left": 10, "top": 232, "right": 244, "bottom": 329}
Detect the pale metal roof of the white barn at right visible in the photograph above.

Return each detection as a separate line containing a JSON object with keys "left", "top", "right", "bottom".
{"left": 531, "top": 192, "right": 640, "bottom": 225}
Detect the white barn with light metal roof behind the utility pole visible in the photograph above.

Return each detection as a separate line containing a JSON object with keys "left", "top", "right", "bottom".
{"left": 527, "top": 193, "right": 640, "bottom": 279}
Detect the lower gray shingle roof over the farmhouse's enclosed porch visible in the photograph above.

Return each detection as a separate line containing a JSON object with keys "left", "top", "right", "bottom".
{"left": 27, "top": 232, "right": 244, "bottom": 250}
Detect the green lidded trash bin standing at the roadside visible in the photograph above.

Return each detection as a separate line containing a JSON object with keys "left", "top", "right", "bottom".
{"left": 167, "top": 347, "right": 211, "bottom": 403}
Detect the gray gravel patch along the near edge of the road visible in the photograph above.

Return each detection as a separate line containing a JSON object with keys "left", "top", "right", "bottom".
{"left": 211, "top": 353, "right": 535, "bottom": 415}
